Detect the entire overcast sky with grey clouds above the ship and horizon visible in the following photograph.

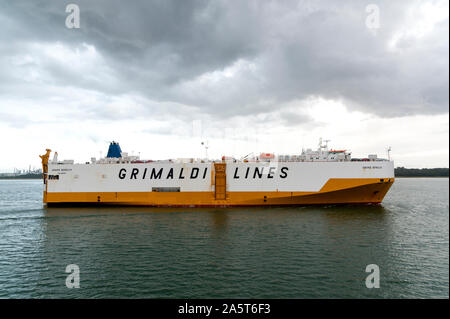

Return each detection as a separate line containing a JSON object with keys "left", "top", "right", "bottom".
{"left": 0, "top": 0, "right": 449, "bottom": 171}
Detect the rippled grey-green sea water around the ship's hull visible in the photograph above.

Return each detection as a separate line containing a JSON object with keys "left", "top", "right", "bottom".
{"left": 0, "top": 178, "right": 449, "bottom": 298}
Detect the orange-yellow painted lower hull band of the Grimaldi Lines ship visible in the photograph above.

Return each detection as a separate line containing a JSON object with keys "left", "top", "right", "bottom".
{"left": 44, "top": 178, "right": 394, "bottom": 206}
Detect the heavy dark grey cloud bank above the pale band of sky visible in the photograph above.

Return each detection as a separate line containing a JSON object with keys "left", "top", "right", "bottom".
{"left": 0, "top": 0, "right": 449, "bottom": 121}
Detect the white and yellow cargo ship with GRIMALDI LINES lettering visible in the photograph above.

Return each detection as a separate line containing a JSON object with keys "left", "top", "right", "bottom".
{"left": 40, "top": 140, "right": 395, "bottom": 207}
